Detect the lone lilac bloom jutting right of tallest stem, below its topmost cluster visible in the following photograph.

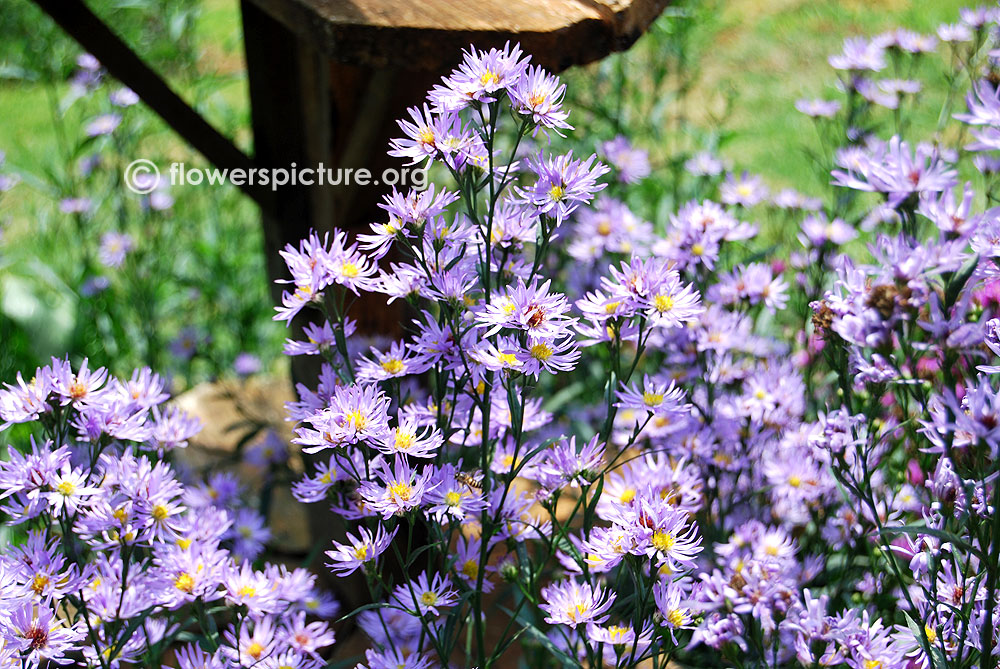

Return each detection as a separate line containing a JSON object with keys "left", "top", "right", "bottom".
{"left": 516, "top": 151, "right": 608, "bottom": 225}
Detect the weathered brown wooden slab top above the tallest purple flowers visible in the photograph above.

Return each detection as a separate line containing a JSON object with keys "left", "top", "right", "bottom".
{"left": 240, "top": 0, "right": 668, "bottom": 71}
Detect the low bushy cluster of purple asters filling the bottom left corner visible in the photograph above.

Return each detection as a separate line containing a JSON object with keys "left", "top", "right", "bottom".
{"left": 0, "top": 359, "right": 338, "bottom": 669}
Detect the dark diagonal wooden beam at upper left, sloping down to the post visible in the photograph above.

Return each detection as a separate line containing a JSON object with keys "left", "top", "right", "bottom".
{"left": 34, "top": 0, "right": 267, "bottom": 207}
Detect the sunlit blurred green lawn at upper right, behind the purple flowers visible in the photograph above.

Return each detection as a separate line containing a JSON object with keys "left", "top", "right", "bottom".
{"left": 693, "top": 0, "right": 969, "bottom": 191}
